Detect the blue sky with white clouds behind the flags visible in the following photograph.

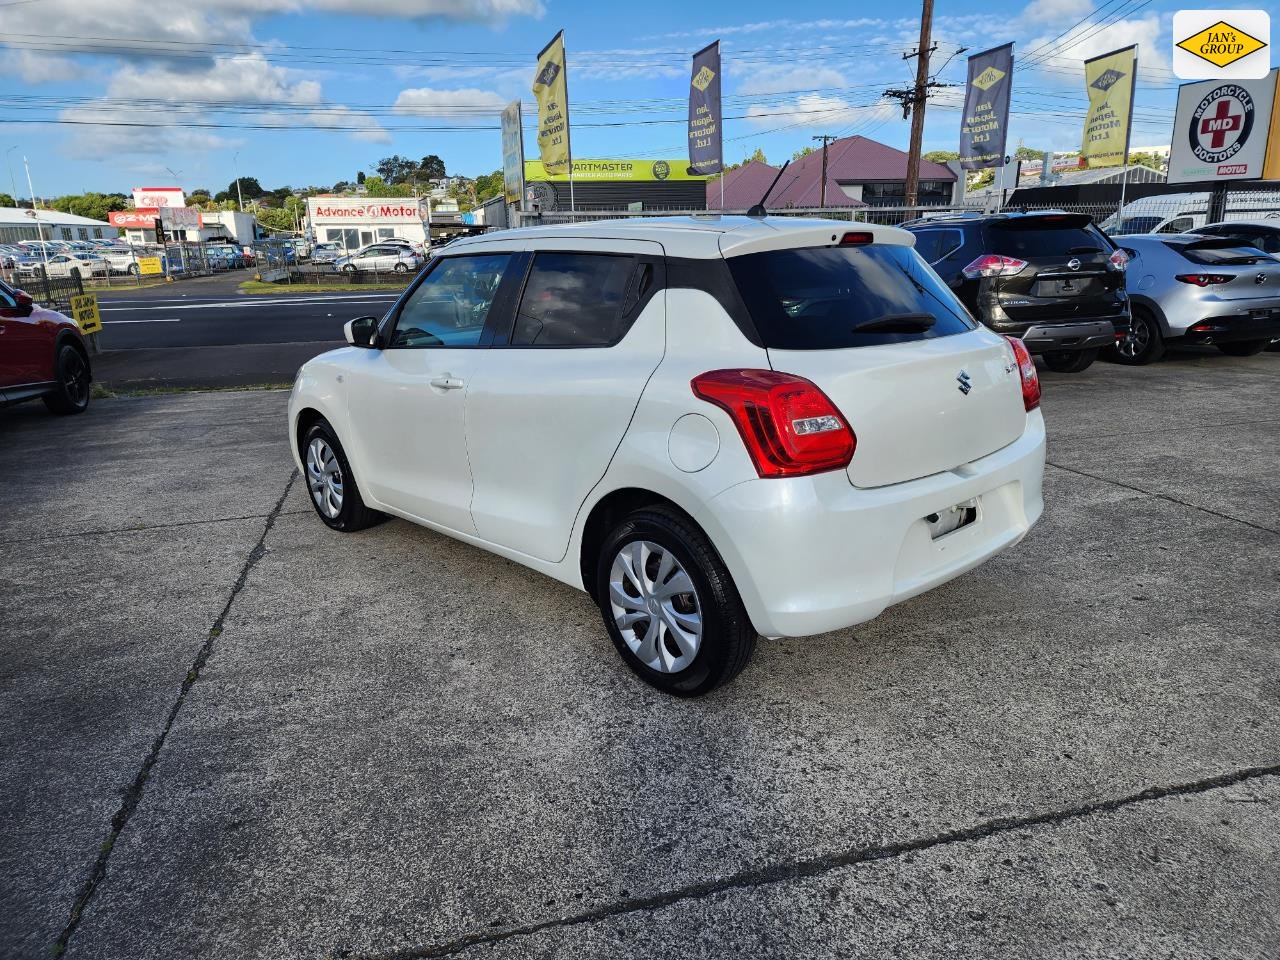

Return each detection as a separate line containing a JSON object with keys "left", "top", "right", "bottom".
{"left": 0, "top": 0, "right": 1249, "bottom": 196}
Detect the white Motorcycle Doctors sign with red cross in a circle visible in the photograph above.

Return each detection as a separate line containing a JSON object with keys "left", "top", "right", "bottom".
{"left": 1169, "top": 70, "right": 1280, "bottom": 183}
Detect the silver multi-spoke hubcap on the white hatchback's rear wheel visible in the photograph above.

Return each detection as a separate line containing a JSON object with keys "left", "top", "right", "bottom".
{"left": 609, "top": 540, "right": 703, "bottom": 673}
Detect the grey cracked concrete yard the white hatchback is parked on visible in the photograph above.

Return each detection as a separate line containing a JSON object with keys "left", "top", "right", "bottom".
{"left": 0, "top": 348, "right": 1280, "bottom": 960}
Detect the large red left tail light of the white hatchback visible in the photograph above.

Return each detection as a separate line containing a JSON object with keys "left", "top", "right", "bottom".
{"left": 690, "top": 370, "right": 858, "bottom": 477}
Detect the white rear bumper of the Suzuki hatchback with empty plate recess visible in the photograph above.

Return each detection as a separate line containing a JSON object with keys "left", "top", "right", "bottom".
{"left": 696, "top": 411, "right": 1044, "bottom": 636}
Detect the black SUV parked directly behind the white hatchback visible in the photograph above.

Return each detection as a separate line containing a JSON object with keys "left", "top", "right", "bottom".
{"left": 902, "top": 212, "right": 1129, "bottom": 374}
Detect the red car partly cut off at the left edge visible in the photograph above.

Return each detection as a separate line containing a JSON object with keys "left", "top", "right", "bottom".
{"left": 0, "top": 280, "right": 93, "bottom": 413}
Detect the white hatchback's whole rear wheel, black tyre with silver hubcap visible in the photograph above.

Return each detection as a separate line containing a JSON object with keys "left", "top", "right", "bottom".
{"left": 595, "top": 507, "right": 755, "bottom": 696}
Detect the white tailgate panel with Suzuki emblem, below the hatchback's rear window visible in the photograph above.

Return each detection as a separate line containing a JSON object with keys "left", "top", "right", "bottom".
{"left": 769, "top": 330, "right": 1027, "bottom": 486}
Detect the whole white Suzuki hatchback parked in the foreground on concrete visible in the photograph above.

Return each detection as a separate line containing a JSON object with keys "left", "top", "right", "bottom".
{"left": 289, "top": 218, "right": 1044, "bottom": 696}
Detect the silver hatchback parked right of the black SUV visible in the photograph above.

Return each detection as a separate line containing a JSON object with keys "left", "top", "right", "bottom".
{"left": 1112, "top": 233, "right": 1280, "bottom": 364}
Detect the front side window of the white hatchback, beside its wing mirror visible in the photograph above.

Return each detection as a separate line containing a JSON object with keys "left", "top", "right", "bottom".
{"left": 388, "top": 253, "right": 511, "bottom": 349}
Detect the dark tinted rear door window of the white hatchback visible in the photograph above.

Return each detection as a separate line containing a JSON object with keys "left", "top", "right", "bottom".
{"left": 511, "top": 253, "right": 635, "bottom": 347}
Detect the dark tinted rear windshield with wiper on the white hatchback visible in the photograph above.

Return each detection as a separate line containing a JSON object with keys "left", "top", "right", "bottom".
{"left": 728, "top": 243, "right": 975, "bottom": 349}
